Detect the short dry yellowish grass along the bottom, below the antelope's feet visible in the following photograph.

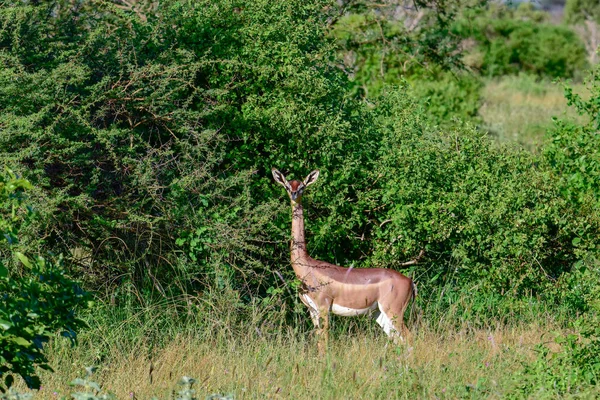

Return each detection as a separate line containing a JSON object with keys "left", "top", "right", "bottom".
{"left": 19, "top": 323, "right": 554, "bottom": 399}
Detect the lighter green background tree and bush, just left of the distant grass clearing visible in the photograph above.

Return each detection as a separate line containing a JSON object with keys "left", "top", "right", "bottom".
{"left": 331, "top": 1, "right": 485, "bottom": 124}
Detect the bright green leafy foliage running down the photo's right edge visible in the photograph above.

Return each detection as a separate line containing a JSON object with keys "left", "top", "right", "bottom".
{"left": 508, "top": 64, "right": 600, "bottom": 398}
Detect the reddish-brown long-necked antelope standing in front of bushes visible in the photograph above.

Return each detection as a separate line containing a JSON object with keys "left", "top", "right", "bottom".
{"left": 271, "top": 168, "right": 423, "bottom": 354}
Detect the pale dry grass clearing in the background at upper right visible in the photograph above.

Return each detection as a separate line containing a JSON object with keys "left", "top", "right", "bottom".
{"left": 479, "top": 76, "right": 584, "bottom": 151}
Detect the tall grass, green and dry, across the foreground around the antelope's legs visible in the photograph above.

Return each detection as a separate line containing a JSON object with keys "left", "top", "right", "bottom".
{"left": 14, "top": 292, "right": 576, "bottom": 399}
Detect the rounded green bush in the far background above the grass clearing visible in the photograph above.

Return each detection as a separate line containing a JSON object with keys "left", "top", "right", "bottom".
{"left": 453, "top": 3, "right": 587, "bottom": 78}
